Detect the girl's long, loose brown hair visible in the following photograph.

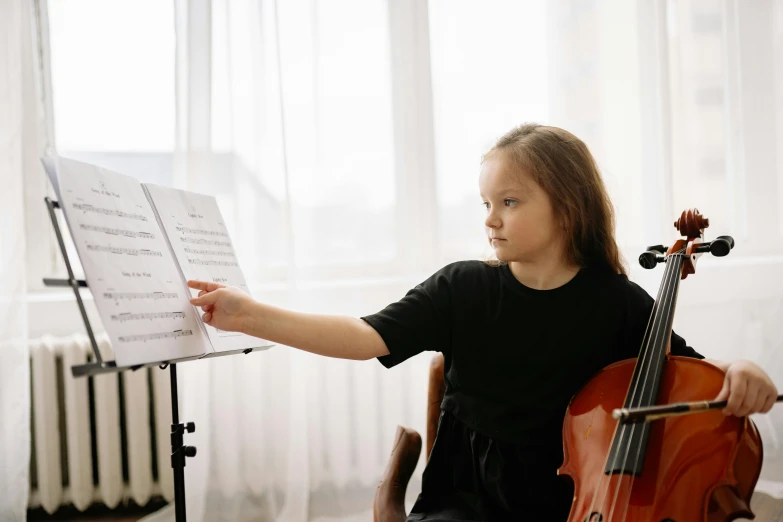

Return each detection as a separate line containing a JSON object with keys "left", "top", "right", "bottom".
{"left": 481, "top": 123, "right": 627, "bottom": 275}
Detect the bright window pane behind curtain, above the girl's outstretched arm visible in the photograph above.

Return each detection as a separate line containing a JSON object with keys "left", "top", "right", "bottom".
{"left": 212, "top": 0, "right": 397, "bottom": 280}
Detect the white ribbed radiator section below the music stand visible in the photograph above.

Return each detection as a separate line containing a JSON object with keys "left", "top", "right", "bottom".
{"left": 29, "top": 335, "right": 174, "bottom": 513}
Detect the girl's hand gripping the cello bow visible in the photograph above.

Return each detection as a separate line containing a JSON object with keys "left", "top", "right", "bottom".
{"left": 715, "top": 361, "right": 778, "bottom": 417}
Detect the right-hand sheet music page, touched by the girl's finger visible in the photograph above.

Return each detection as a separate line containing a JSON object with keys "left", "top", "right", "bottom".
{"left": 144, "top": 183, "right": 272, "bottom": 351}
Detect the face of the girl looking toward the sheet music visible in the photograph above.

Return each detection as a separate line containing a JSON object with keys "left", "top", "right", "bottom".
{"left": 479, "top": 151, "right": 564, "bottom": 263}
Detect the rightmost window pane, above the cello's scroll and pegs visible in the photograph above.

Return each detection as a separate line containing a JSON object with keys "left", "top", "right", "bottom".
{"left": 666, "top": 0, "right": 783, "bottom": 257}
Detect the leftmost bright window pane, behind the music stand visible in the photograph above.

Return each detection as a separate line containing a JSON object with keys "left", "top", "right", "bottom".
{"left": 27, "top": 0, "right": 175, "bottom": 290}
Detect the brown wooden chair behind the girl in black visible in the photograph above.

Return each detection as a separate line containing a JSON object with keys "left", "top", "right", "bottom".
{"left": 372, "top": 353, "right": 446, "bottom": 522}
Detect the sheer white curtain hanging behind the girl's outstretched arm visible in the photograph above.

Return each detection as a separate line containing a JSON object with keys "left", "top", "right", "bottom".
{"left": 140, "top": 0, "right": 437, "bottom": 522}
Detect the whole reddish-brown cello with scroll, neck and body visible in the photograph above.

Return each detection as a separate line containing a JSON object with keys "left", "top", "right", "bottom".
{"left": 558, "top": 209, "right": 763, "bottom": 522}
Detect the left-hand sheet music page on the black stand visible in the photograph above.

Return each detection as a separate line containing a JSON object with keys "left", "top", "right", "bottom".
{"left": 57, "top": 158, "right": 209, "bottom": 366}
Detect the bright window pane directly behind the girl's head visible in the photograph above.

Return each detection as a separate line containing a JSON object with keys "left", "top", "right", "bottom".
{"left": 429, "top": 0, "right": 549, "bottom": 261}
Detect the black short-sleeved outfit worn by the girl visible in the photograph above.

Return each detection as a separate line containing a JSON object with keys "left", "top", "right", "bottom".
{"left": 362, "top": 261, "right": 703, "bottom": 521}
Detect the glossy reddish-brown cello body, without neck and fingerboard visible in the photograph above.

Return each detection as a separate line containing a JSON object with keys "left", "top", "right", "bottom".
{"left": 559, "top": 355, "right": 762, "bottom": 522}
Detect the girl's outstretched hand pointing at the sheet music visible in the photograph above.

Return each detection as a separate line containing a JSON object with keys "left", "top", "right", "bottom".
{"left": 188, "top": 280, "right": 254, "bottom": 332}
